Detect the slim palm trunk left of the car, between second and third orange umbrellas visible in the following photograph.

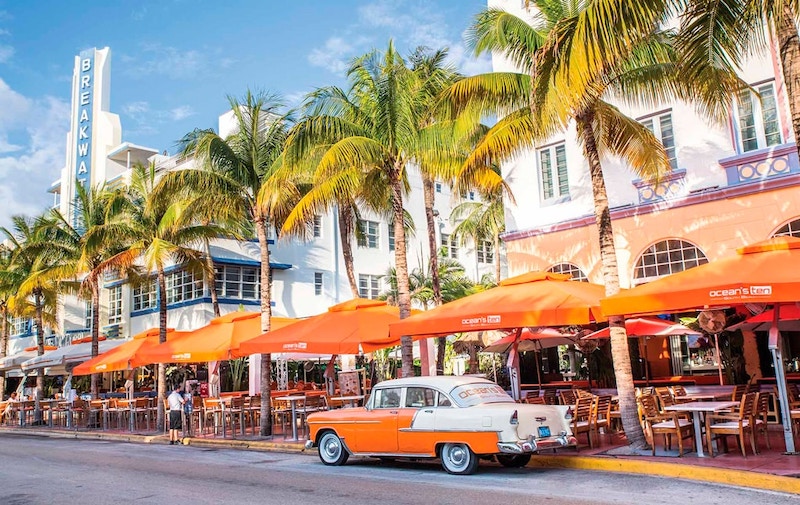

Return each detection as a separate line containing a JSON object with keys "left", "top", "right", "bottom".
{"left": 255, "top": 216, "right": 272, "bottom": 437}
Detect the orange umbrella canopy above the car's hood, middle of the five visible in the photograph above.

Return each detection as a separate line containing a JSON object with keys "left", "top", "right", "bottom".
{"left": 237, "top": 298, "right": 400, "bottom": 356}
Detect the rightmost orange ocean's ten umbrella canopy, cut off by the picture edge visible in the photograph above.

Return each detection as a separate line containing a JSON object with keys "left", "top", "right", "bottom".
{"left": 601, "top": 237, "right": 800, "bottom": 315}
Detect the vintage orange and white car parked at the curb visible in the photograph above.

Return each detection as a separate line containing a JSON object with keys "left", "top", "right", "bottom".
{"left": 306, "top": 376, "right": 577, "bottom": 474}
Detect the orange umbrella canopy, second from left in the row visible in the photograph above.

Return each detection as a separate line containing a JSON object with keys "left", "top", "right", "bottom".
{"left": 141, "top": 312, "right": 297, "bottom": 363}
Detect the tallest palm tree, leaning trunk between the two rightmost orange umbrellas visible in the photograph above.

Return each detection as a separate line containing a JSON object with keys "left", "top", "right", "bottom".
{"left": 448, "top": 0, "right": 737, "bottom": 447}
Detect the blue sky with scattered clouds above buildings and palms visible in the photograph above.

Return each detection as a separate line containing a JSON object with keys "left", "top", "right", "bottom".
{"left": 0, "top": 0, "right": 491, "bottom": 227}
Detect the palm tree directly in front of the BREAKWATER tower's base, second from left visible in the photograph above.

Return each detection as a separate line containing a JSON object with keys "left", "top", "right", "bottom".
{"left": 34, "top": 184, "right": 135, "bottom": 398}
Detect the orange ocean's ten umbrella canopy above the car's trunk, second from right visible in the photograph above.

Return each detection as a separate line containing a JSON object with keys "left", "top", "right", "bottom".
{"left": 390, "top": 272, "right": 605, "bottom": 338}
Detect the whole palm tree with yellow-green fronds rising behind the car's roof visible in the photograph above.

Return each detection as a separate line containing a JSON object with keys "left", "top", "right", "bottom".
{"left": 287, "top": 42, "right": 466, "bottom": 376}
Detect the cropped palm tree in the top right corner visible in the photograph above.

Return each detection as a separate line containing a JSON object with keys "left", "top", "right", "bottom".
{"left": 674, "top": 0, "right": 800, "bottom": 158}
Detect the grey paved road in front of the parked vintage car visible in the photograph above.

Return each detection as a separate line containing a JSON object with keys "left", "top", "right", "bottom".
{"left": 0, "top": 434, "right": 798, "bottom": 505}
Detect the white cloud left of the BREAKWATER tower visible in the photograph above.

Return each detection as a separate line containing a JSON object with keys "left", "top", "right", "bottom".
{"left": 0, "top": 79, "right": 69, "bottom": 226}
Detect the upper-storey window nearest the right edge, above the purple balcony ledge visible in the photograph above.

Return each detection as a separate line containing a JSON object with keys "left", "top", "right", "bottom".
{"left": 736, "top": 82, "right": 781, "bottom": 152}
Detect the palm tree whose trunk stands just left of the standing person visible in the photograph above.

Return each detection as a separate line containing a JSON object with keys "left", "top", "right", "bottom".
{"left": 101, "top": 165, "right": 225, "bottom": 429}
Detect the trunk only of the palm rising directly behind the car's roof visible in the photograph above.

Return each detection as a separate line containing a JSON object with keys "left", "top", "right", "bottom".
{"left": 389, "top": 160, "right": 414, "bottom": 377}
